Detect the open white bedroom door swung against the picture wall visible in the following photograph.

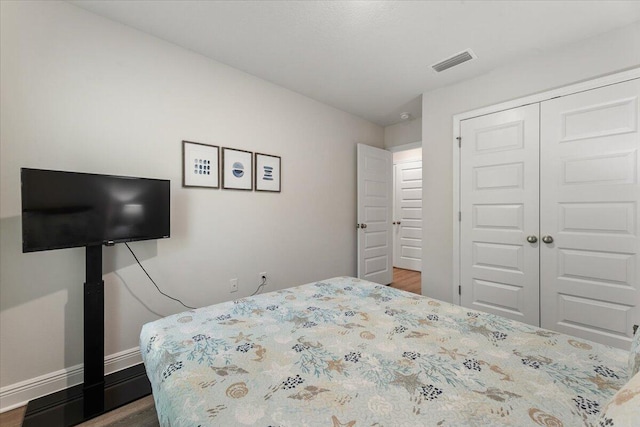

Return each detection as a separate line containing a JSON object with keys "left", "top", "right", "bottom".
{"left": 356, "top": 144, "right": 393, "bottom": 285}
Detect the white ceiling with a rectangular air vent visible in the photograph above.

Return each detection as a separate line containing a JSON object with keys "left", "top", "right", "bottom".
{"left": 70, "top": 0, "right": 640, "bottom": 126}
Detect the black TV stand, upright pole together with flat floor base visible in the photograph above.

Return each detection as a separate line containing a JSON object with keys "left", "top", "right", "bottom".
{"left": 23, "top": 245, "right": 151, "bottom": 427}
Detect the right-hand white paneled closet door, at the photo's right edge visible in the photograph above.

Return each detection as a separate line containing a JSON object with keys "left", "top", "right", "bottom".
{"left": 540, "top": 80, "right": 640, "bottom": 349}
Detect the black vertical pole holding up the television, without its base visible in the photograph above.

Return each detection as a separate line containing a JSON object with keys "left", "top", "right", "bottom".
{"left": 82, "top": 245, "right": 104, "bottom": 418}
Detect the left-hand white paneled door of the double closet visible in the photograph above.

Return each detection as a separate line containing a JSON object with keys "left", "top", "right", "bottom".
{"left": 460, "top": 104, "right": 540, "bottom": 326}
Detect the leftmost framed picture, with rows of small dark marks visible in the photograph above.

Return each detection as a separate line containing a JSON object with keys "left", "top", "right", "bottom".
{"left": 182, "top": 141, "right": 220, "bottom": 188}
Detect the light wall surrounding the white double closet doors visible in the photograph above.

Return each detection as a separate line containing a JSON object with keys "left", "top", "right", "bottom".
{"left": 422, "top": 23, "right": 640, "bottom": 301}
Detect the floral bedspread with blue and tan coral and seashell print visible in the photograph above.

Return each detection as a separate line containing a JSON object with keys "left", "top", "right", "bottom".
{"left": 140, "top": 277, "right": 628, "bottom": 427}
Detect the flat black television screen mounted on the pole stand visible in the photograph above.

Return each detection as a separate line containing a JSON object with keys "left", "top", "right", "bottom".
{"left": 21, "top": 168, "right": 170, "bottom": 252}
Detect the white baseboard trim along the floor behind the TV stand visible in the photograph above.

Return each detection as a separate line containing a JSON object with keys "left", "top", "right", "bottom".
{"left": 0, "top": 347, "right": 142, "bottom": 413}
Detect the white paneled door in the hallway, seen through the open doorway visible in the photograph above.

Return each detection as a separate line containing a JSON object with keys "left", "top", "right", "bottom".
{"left": 392, "top": 161, "right": 422, "bottom": 271}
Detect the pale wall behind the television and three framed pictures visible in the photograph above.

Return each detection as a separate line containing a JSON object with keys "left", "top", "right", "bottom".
{"left": 0, "top": 1, "right": 384, "bottom": 409}
